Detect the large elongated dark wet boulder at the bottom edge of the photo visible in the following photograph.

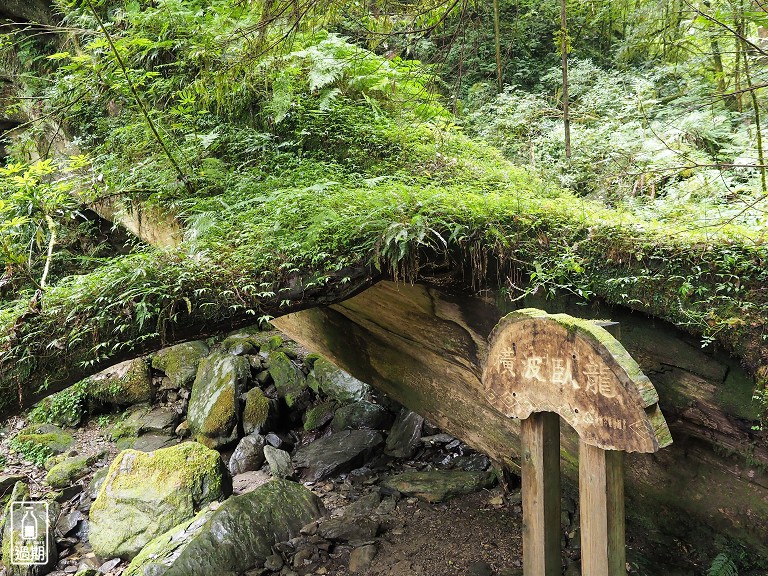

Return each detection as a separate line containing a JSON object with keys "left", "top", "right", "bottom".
{"left": 123, "top": 480, "right": 325, "bottom": 576}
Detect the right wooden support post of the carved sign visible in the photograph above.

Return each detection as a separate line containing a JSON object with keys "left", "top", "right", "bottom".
{"left": 579, "top": 441, "right": 627, "bottom": 576}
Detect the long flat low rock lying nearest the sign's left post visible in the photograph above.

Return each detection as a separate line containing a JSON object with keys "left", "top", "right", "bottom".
{"left": 381, "top": 470, "right": 496, "bottom": 502}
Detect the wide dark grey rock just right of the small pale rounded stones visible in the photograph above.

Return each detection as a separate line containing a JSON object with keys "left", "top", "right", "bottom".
{"left": 293, "top": 430, "right": 384, "bottom": 481}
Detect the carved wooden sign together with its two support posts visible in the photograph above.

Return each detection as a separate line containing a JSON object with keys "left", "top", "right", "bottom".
{"left": 483, "top": 308, "right": 672, "bottom": 576}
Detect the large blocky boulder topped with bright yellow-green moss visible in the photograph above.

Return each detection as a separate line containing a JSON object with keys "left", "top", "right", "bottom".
{"left": 90, "top": 442, "right": 231, "bottom": 558}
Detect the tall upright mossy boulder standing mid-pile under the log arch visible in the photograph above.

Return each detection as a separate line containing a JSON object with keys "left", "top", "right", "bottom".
{"left": 187, "top": 352, "right": 251, "bottom": 448}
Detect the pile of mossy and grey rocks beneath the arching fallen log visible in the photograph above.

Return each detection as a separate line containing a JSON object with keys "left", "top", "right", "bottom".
{"left": 0, "top": 331, "right": 536, "bottom": 576}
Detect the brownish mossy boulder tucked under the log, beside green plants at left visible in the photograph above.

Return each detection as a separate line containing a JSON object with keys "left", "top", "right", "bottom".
{"left": 88, "top": 358, "right": 152, "bottom": 406}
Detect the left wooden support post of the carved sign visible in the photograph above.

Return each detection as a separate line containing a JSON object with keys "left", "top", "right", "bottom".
{"left": 520, "top": 412, "right": 562, "bottom": 576}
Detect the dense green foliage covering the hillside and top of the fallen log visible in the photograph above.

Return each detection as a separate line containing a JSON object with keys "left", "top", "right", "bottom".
{"left": 0, "top": 0, "right": 768, "bottom": 432}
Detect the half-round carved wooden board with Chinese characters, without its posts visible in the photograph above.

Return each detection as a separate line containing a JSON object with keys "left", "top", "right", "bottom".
{"left": 483, "top": 308, "right": 672, "bottom": 452}
